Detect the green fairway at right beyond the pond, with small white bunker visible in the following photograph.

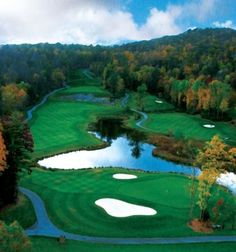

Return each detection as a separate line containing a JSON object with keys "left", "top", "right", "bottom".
{"left": 130, "top": 112, "right": 236, "bottom": 145}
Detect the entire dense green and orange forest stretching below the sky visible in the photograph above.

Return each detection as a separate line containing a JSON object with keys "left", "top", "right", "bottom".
{"left": 0, "top": 29, "right": 236, "bottom": 119}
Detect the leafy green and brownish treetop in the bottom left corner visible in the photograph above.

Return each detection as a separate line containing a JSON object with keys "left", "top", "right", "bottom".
{"left": 0, "top": 221, "right": 31, "bottom": 252}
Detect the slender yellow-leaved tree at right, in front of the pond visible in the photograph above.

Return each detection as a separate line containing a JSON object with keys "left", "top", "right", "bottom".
{"left": 196, "top": 136, "right": 236, "bottom": 221}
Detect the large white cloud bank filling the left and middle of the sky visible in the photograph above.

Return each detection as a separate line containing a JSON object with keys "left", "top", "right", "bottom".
{"left": 0, "top": 0, "right": 221, "bottom": 44}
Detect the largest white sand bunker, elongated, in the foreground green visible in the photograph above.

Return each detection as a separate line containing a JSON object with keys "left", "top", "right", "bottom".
{"left": 95, "top": 198, "right": 157, "bottom": 217}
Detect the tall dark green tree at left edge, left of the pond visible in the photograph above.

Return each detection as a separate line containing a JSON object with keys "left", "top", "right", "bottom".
{"left": 0, "top": 112, "right": 33, "bottom": 208}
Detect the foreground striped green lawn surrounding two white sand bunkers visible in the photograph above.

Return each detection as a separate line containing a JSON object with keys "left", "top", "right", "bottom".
{"left": 21, "top": 168, "right": 235, "bottom": 237}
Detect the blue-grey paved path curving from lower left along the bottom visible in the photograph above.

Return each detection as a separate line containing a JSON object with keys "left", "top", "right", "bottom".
{"left": 19, "top": 187, "right": 236, "bottom": 244}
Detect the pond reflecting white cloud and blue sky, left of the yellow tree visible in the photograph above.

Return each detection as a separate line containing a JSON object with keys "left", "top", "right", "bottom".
{"left": 38, "top": 119, "right": 200, "bottom": 175}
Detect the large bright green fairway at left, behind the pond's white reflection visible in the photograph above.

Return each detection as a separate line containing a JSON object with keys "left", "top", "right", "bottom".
{"left": 30, "top": 72, "right": 122, "bottom": 157}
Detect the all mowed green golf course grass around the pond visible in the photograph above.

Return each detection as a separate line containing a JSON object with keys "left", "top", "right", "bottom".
{"left": 0, "top": 70, "right": 236, "bottom": 252}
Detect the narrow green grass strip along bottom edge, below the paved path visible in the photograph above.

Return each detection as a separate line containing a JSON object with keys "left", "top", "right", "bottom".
{"left": 31, "top": 237, "right": 236, "bottom": 252}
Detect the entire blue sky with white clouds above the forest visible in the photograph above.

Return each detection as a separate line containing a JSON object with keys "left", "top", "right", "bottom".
{"left": 0, "top": 0, "right": 236, "bottom": 45}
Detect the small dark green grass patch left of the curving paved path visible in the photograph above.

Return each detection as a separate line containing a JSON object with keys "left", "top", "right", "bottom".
{"left": 0, "top": 193, "right": 36, "bottom": 228}
